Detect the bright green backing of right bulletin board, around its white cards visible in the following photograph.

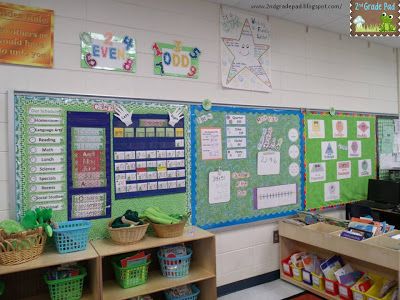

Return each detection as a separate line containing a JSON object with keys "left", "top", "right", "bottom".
{"left": 304, "top": 113, "right": 376, "bottom": 210}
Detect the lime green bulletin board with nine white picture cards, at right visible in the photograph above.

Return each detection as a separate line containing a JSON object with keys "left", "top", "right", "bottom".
{"left": 304, "top": 113, "right": 376, "bottom": 210}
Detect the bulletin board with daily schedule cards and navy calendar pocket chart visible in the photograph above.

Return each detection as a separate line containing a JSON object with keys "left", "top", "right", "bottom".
{"left": 14, "top": 93, "right": 191, "bottom": 239}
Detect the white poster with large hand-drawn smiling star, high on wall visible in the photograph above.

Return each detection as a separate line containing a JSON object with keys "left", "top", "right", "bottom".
{"left": 220, "top": 6, "right": 272, "bottom": 92}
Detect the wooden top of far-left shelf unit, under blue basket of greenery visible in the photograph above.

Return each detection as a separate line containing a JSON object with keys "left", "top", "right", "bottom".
{"left": 0, "top": 243, "right": 98, "bottom": 275}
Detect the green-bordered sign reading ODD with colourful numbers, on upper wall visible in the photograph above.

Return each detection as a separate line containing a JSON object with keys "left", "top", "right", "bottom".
{"left": 153, "top": 41, "right": 201, "bottom": 79}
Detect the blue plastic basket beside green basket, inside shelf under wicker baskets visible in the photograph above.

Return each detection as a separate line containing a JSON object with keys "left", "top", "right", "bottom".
{"left": 157, "top": 248, "right": 192, "bottom": 278}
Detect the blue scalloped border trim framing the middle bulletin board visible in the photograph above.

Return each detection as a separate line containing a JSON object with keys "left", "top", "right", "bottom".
{"left": 190, "top": 105, "right": 305, "bottom": 229}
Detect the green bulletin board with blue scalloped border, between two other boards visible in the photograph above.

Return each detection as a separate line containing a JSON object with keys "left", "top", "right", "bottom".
{"left": 191, "top": 106, "right": 304, "bottom": 229}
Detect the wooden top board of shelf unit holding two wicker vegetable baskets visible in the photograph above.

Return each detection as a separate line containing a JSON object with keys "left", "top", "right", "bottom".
{"left": 91, "top": 226, "right": 214, "bottom": 257}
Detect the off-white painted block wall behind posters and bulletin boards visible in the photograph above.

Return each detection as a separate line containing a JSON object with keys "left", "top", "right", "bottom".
{"left": 0, "top": 0, "right": 398, "bottom": 285}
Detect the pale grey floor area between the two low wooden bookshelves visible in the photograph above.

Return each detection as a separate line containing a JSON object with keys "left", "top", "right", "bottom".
{"left": 218, "top": 279, "right": 303, "bottom": 300}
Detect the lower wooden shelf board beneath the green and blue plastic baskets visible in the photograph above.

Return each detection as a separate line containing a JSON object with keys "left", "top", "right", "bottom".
{"left": 103, "top": 265, "right": 215, "bottom": 300}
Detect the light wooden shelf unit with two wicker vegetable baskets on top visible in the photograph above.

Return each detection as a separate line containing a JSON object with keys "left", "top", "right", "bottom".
{"left": 91, "top": 226, "right": 217, "bottom": 300}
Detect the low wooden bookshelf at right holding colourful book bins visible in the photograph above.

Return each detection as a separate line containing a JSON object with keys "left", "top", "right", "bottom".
{"left": 279, "top": 221, "right": 400, "bottom": 299}
